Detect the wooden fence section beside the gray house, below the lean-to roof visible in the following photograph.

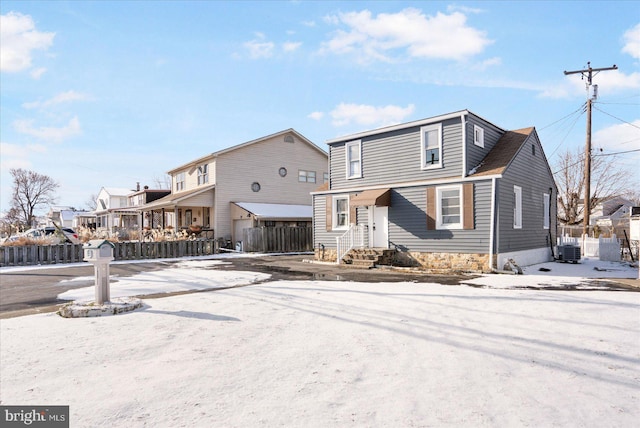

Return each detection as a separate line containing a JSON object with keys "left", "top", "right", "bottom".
{"left": 242, "top": 227, "right": 313, "bottom": 253}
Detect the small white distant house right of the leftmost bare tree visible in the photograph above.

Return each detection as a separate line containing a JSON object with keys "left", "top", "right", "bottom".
{"left": 95, "top": 187, "right": 139, "bottom": 231}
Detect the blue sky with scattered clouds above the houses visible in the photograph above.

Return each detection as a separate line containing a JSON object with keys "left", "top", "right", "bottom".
{"left": 0, "top": 1, "right": 640, "bottom": 211}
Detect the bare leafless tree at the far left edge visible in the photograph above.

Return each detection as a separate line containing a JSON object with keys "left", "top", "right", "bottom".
{"left": 8, "top": 168, "right": 60, "bottom": 226}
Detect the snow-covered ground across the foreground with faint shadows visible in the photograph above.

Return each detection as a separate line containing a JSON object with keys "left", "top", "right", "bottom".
{"left": 0, "top": 260, "right": 640, "bottom": 427}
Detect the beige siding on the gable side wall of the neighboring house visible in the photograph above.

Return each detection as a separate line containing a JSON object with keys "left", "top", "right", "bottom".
{"left": 215, "top": 135, "right": 327, "bottom": 237}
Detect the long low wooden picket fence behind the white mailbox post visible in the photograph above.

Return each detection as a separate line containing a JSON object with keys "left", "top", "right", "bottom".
{"left": 0, "top": 239, "right": 218, "bottom": 267}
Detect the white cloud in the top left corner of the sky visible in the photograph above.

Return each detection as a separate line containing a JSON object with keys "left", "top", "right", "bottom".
{"left": 0, "top": 12, "right": 55, "bottom": 72}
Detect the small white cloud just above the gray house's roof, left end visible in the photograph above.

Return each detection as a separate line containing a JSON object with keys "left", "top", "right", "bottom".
{"left": 329, "top": 103, "right": 415, "bottom": 126}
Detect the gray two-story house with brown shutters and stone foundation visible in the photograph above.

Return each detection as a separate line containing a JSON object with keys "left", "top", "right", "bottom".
{"left": 312, "top": 110, "right": 557, "bottom": 272}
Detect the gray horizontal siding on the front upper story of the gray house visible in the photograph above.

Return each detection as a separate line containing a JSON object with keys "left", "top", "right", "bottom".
{"left": 330, "top": 118, "right": 462, "bottom": 190}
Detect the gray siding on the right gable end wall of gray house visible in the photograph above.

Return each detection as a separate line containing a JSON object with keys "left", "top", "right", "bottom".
{"left": 498, "top": 137, "right": 557, "bottom": 253}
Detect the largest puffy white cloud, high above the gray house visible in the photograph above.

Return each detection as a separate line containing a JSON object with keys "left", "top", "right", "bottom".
{"left": 321, "top": 8, "right": 492, "bottom": 62}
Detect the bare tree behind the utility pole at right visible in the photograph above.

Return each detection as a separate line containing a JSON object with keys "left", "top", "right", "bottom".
{"left": 554, "top": 150, "right": 633, "bottom": 225}
